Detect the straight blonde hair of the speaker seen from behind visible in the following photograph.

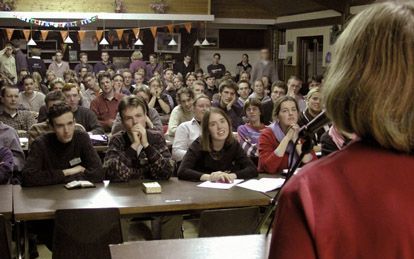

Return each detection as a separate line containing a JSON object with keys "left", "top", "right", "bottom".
{"left": 323, "top": 1, "right": 414, "bottom": 153}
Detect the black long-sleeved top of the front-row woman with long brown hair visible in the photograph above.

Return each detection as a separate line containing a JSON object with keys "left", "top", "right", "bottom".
{"left": 178, "top": 138, "right": 257, "bottom": 181}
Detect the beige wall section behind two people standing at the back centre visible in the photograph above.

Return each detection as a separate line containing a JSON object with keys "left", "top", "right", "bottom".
{"left": 198, "top": 49, "right": 260, "bottom": 75}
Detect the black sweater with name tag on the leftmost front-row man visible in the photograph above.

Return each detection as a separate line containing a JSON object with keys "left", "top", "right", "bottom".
{"left": 22, "top": 131, "right": 103, "bottom": 186}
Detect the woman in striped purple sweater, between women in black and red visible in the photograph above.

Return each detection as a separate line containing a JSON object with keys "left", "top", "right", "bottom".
{"left": 237, "top": 98, "right": 265, "bottom": 165}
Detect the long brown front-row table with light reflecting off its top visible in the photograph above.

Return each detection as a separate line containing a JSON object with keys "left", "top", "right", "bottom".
{"left": 13, "top": 178, "right": 270, "bottom": 221}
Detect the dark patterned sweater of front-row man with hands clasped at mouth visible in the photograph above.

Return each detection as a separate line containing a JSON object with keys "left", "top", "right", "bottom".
{"left": 103, "top": 129, "right": 174, "bottom": 181}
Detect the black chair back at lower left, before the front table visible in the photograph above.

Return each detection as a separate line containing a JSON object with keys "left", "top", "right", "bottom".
{"left": 52, "top": 208, "right": 122, "bottom": 259}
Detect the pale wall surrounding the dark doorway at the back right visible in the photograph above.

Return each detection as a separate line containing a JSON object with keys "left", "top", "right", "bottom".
{"left": 286, "top": 26, "right": 332, "bottom": 67}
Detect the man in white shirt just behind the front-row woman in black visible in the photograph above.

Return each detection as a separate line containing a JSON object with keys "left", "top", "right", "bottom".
{"left": 172, "top": 94, "right": 211, "bottom": 162}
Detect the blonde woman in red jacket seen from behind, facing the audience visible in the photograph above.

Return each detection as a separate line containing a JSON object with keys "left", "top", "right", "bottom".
{"left": 269, "top": 1, "right": 414, "bottom": 258}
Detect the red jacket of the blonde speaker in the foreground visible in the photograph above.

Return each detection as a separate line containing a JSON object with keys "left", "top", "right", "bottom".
{"left": 269, "top": 142, "right": 414, "bottom": 259}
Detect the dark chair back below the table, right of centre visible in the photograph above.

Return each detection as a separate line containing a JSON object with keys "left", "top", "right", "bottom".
{"left": 199, "top": 207, "right": 260, "bottom": 237}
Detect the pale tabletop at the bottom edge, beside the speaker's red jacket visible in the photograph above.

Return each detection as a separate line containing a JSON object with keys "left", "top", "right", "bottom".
{"left": 109, "top": 235, "right": 271, "bottom": 259}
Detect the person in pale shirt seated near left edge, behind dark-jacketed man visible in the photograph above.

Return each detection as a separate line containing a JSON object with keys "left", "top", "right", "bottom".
{"left": 19, "top": 75, "right": 45, "bottom": 113}
